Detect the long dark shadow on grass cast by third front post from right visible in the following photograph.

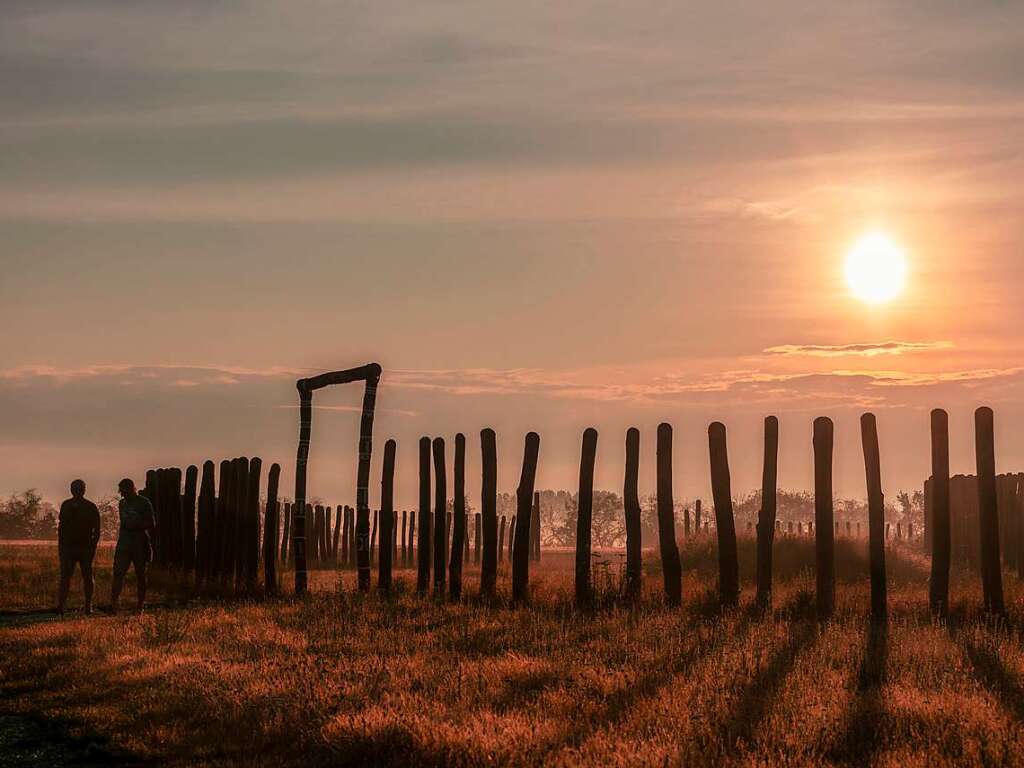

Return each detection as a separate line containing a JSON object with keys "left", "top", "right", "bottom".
{"left": 828, "top": 622, "right": 889, "bottom": 765}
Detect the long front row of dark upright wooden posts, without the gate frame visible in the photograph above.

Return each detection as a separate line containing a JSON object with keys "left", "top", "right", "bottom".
{"left": 143, "top": 408, "right": 1004, "bottom": 617}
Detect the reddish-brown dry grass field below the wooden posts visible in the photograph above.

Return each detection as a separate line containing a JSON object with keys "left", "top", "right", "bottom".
{"left": 0, "top": 539, "right": 1024, "bottom": 767}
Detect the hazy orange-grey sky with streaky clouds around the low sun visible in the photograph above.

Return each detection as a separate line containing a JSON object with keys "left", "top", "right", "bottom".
{"left": 0, "top": 0, "right": 1024, "bottom": 508}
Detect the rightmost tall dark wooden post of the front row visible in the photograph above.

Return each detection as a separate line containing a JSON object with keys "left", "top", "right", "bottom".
{"left": 974, "top": 408, "right": 1005, "bottom": 614}
